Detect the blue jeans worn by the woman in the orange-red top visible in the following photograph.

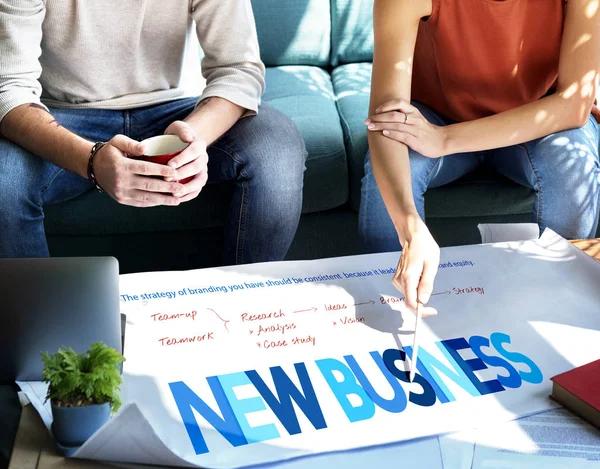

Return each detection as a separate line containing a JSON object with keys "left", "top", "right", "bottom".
{"left": 359, "top": 102, "right": 600, "bottom": 252}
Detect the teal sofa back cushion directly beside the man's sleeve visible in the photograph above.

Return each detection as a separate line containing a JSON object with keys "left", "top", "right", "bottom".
{"left": 252, "top": 0, "right": 331, "bottom": 66}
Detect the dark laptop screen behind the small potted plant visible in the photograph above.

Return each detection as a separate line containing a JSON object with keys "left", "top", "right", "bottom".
{"left": 0, "top": 257, "right": 124, "bottom": 382}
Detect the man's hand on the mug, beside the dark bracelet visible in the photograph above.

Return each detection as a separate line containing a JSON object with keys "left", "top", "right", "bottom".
{"left": 94, "top": 135, "right": 186, "bottom": 207}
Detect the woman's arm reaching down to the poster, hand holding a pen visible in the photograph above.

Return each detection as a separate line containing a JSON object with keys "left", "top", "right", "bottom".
{"left": 369, "top": 0, "right": 439, "bottom": 309}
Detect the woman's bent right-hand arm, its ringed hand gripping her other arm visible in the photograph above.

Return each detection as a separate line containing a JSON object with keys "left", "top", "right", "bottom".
{"left": 370, "top": 0, "right": 600, "bottom": 157}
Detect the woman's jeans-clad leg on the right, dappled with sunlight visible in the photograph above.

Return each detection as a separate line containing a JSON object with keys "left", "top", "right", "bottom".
{"left": 485, "top": 117, "right": 600, "bottom": 239}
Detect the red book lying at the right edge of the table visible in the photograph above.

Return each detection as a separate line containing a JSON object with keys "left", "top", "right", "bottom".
{"left": 550, "top": 360, "right": 600, "bottom": 428}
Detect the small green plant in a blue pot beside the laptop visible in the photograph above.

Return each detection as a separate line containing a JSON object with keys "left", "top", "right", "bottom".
{"left": 42, "top": 342, "right": 125, "bottom": 456}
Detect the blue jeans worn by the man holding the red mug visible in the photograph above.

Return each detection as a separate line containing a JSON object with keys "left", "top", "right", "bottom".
{"left": 0, "top": 98, "right": 306, "bottom": 264}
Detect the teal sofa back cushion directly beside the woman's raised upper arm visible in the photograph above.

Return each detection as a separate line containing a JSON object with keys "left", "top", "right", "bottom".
{"left": 331, "top": 0, "right": 373, "bottom": 66}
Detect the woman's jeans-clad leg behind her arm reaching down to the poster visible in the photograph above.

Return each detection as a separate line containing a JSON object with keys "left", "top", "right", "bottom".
{"left": 359, "top": 102, "right": 480, "bottom": 253}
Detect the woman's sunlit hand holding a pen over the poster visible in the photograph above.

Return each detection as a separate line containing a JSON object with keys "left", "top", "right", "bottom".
{"left": 393, "top": 219, "right": 440, "bottom": 316}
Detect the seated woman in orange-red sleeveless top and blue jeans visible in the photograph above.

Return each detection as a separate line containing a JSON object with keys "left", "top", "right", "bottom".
{"left": 360, "top": 0, "right": 600, "bottom": 309}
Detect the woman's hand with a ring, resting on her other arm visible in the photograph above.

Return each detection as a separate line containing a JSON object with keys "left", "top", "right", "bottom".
{"left": 365, "top": 99, "right": 446, "bottom": 158}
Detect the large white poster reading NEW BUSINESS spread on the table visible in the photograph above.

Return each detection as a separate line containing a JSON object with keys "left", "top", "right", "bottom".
{"left": 34, "top": 232, "right": 600, "bottom": 468}
